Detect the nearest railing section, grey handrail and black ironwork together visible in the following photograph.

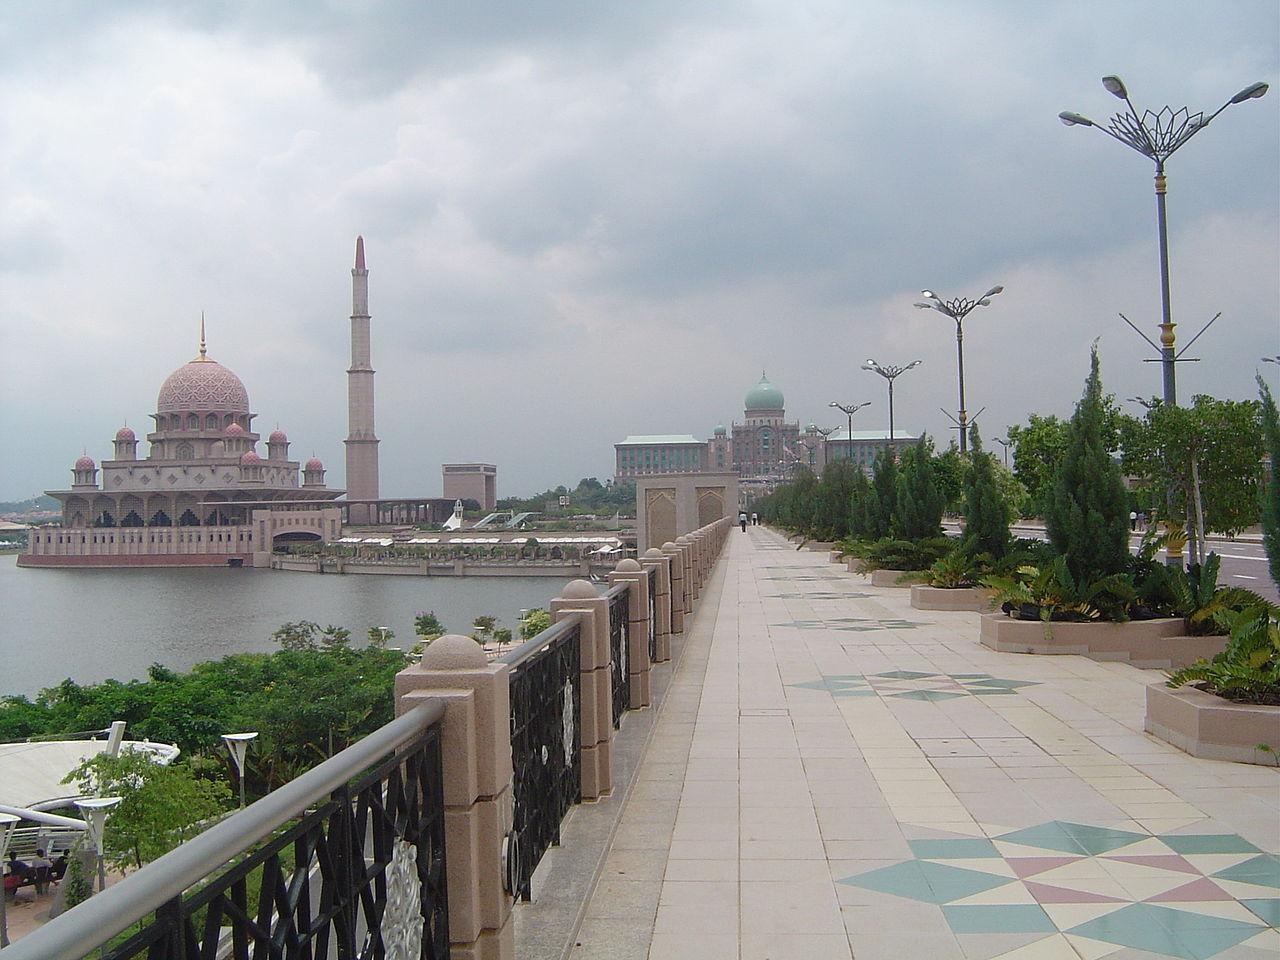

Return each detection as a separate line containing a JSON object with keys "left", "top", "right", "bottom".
{"left": 5, "top": 701, "right": 449, "bottom": 960}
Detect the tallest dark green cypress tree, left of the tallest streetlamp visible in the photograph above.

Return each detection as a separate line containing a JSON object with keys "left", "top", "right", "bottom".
{"left": 1044, "top": 344, "right": 1129, "bottom": 584}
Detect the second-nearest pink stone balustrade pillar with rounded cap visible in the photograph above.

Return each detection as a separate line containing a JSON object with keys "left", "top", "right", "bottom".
{"left": 552, "top": 580, "right": 613, "bottom": 800}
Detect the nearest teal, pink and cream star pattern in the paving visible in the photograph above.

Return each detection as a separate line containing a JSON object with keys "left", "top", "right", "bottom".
{"left": 840, "top": 824, "right": 1280, "bottom": 960}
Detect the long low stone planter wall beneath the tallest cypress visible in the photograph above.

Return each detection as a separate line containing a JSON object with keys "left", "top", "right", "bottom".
{"left": 980, "top": 613, "right": 1208, "bottom": 669}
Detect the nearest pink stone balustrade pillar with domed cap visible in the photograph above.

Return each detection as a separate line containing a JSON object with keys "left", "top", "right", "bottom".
{"left": 396, "top": 635, "right": 516, "bottom": 960}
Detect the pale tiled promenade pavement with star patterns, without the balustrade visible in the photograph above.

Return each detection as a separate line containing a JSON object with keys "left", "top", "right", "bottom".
{"left": 573, "top": 527, "right": 1280, "bottom": 960}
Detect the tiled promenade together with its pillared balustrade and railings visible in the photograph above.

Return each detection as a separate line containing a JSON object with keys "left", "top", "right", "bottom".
{"left": 6, "top": 521, "right": 1280, "bottom": 960}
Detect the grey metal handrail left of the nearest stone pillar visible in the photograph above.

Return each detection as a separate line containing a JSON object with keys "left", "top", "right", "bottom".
{"left": 4, "top": 700, "right": 444, "bottom": 960}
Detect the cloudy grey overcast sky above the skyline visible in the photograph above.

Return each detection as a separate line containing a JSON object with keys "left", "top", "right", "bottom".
{"left": 0, "top": 0, "right": 1280, "bottom": 499}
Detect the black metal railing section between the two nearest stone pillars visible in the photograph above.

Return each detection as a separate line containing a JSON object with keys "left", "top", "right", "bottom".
{"left": 500, "top": 617, "right": 582, "bottom": 900}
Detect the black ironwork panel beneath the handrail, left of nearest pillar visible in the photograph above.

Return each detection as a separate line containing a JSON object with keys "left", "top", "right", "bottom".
{"left": 102, "top": 724, "right": 449, "bottom": 960}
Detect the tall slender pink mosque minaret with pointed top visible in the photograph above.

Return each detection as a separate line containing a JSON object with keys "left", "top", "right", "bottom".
{"left": 346, "top": 237, "right": 378, "bottom": 524}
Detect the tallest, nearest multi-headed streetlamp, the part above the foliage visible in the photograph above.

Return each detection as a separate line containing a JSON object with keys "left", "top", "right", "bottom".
{"left": 1057, "top": 77, "right": 1267, "bottom": 406}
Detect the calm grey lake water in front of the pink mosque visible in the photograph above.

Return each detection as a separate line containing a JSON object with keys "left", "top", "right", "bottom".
{"left": 0, "top": 554, "right": 567, "bottom": 696}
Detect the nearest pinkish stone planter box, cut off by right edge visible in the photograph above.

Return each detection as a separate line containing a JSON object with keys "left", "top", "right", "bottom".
{"left": 1144, "top": 684, "right": 1280, "bottom": 767}
